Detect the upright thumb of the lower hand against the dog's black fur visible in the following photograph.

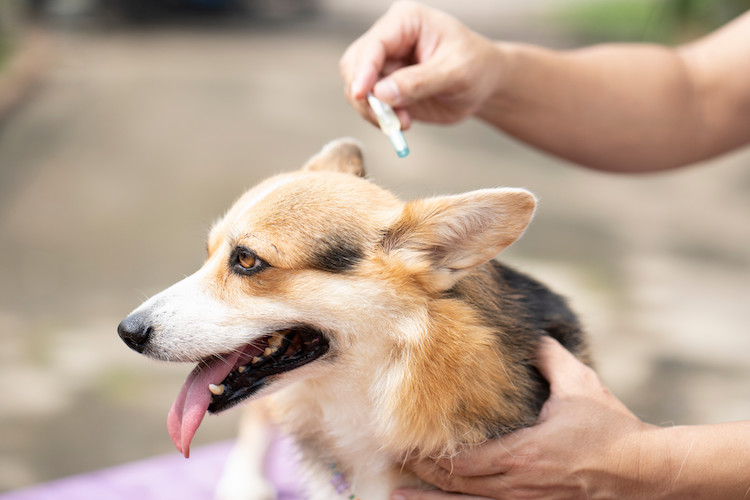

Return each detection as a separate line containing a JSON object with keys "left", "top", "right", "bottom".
{"left": 536, "top": 337, "right": 600, "bottom": 395}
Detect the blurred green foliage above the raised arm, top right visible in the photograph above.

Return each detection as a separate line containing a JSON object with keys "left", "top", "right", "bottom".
{"left": 554, "top": 0, "right": 750, "bottom": 44}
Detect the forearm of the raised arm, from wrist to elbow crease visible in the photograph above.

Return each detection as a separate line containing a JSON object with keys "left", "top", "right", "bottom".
{"left": 479, "top": 42, "right": 714, "bottom": 171}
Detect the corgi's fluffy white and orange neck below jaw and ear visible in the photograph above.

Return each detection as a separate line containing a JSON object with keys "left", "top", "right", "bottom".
{"left": 275, "top": 292, "right": 522, "bottom": 458}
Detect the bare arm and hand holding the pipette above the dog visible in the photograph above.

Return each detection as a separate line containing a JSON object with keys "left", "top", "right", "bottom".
{"left": 340, "top": 2, "right": 750, "bottom": 172}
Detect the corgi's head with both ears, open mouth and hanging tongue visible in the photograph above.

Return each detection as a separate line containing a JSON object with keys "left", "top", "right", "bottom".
{"left": 118, "top": 139, "right": 535, "bottom": 454}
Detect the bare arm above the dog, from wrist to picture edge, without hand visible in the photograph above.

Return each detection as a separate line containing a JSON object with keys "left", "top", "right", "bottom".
{"left": 480, "top": 7, "right": 750, "bottom": 172}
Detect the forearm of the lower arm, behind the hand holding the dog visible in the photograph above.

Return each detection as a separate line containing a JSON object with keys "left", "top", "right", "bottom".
{"left": 588, "top": 421, "right": 750, "bottom": 500}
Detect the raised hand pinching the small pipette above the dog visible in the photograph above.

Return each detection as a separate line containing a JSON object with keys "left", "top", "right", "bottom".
{"left": 339, "top": 1, "right": 503, "bottom": 129}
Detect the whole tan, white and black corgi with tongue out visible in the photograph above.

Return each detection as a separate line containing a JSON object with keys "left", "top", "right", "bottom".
{"left": 118, "top": 139, "right": 587, "bottom": 500}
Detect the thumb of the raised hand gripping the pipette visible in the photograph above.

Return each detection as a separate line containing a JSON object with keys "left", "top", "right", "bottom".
{"left": 372, "top": 62, "right": 446, "bottom": 108}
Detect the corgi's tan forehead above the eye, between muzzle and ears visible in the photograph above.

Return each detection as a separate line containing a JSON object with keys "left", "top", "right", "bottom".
{"left": 209, "top": 172, "right": 401, "bottom": 266}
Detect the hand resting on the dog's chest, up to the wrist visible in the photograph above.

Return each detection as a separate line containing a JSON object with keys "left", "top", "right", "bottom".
{"left": 391, "top": 338, "right": 664, "bottom": 500}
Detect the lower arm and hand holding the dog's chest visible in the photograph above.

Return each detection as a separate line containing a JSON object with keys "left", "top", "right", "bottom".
{"left": 391, "top": 339, "right": 750, "bottom": 500}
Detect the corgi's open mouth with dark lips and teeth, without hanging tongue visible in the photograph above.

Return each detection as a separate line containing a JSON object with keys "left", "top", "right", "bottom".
{"left": 208, "top": 327, "right": 328, "bottom": 413}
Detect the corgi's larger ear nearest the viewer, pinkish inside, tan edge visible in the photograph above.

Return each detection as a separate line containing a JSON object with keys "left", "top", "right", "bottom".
{"left": 382, "top": 189, "right": 536, "bottom": 292}
